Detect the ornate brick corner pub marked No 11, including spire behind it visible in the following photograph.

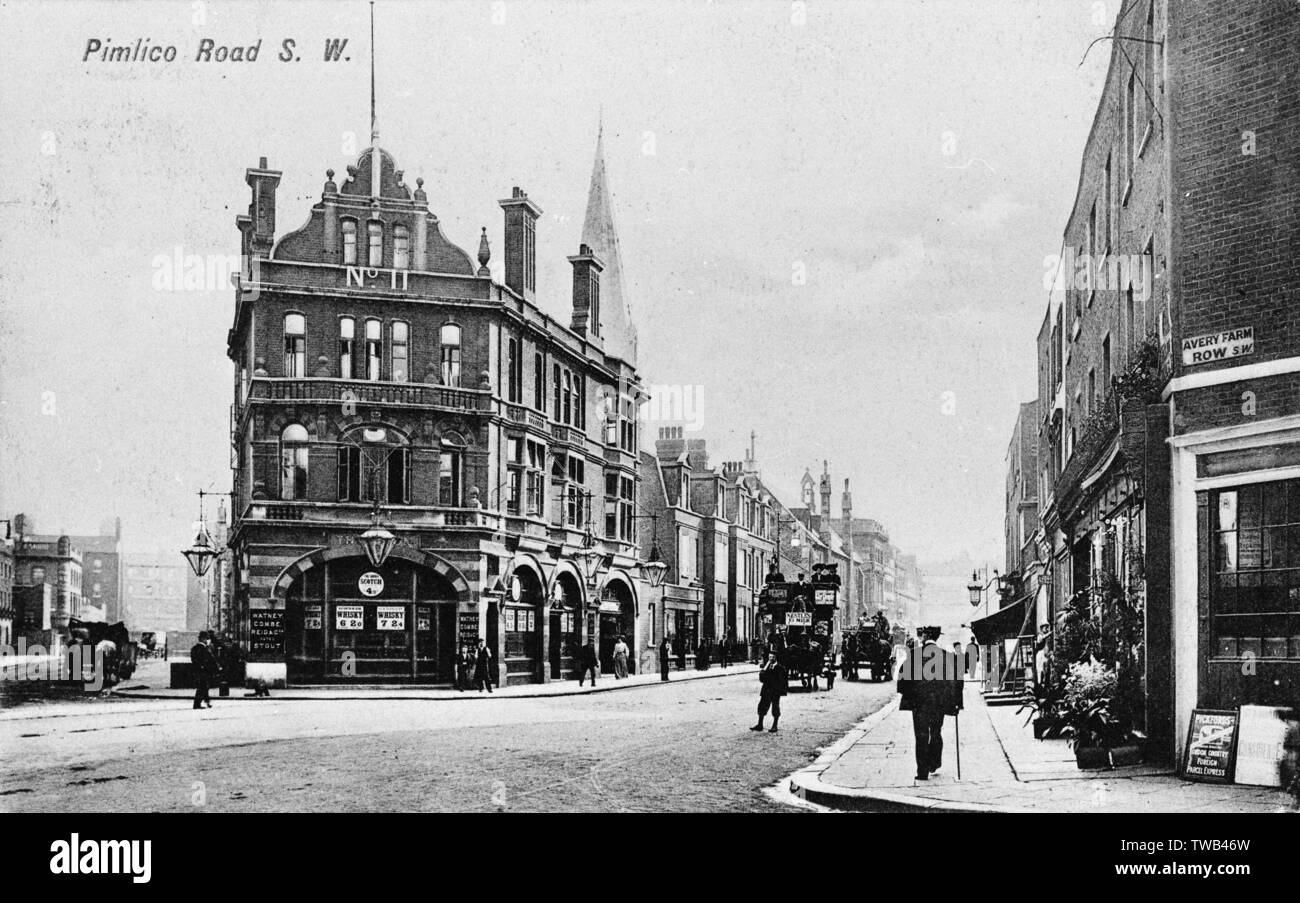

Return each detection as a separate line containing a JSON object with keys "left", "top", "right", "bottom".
{"left": 228, "top": 133, "right": 650, "bottom": 686}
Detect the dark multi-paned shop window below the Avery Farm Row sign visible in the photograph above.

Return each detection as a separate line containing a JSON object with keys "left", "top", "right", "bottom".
{"left": 1206, "top": 479, "right": 1300, "bottom": 659}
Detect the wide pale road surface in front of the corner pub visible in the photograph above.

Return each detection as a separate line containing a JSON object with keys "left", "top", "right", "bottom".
{"left": 0, "top": 674, "right": 893, "bottom": 812}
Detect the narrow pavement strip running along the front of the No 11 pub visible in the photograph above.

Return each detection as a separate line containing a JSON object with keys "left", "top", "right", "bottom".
{"left": 114, "top": 663, "right": 758, "bottom": 702}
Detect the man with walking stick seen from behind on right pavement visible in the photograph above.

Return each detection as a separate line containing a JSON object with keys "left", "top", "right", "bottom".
{"left": 898, "top": 628, "right": 965, "bottom": 781}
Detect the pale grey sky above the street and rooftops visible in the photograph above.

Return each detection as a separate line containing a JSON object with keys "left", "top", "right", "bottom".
{"left": 0, "top": 0, "right": 1118, "bottom": 587}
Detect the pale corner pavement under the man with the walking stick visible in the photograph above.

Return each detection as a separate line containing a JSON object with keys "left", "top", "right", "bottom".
{"left": 789, "top": 686, "right": 1297, "bottom": 812}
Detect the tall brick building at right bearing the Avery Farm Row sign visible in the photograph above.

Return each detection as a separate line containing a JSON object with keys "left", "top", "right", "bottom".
{"left": 1029, "top": 0, "right": 1300, "bottom": 755}
